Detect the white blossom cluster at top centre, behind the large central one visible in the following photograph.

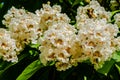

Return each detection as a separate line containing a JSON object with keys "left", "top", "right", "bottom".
{"left": 35, "top": 3, "right": 70, "bottom": 31}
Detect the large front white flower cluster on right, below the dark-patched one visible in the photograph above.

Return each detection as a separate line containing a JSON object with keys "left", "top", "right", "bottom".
{"left": 78, "top": 19, "right": 119, "bottom": 68}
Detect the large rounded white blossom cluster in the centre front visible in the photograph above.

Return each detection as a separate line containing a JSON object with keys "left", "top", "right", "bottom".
{"left": 39, "top": 22, "right": 76, "bottom": 70}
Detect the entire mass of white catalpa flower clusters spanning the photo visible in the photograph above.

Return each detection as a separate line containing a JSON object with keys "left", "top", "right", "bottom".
{"left": 0, "top": 0, "right": 120, "bottom": 71}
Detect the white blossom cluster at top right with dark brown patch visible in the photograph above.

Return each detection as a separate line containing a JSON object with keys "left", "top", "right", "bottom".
{"left": 76, "top": 0, "right": 111, "bottom": 29}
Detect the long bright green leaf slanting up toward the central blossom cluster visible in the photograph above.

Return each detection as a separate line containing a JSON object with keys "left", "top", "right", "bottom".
{"left": 16, "top": 60, "right": 44, "bottom": 80}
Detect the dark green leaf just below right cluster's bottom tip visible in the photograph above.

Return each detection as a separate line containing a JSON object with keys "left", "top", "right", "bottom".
{"left": 97, "top": 59, "right": 115, "bottom": 75}
